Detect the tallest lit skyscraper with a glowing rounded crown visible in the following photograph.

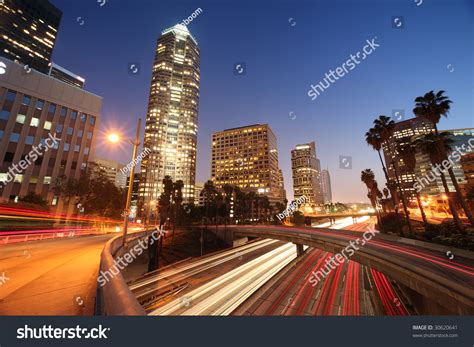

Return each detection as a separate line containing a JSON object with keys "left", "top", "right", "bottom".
{"left": 139, "top": 24, "right": 200, "bottom": 207}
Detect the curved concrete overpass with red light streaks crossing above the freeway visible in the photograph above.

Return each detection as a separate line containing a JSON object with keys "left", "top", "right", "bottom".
{"left": 228, "top": 226, "right": 474, "bottom": 315}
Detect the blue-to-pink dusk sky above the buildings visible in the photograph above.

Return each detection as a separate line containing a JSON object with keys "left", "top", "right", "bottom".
{"left": 52, "top": 0, "right": 474, "bottom": 202}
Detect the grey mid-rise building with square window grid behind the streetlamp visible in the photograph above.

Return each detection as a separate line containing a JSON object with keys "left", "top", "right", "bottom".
{"left": 0, "top": 58, "right": 102, "bottom": 212}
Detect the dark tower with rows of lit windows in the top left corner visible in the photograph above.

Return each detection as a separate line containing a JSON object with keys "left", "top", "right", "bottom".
{"left": 0, "top": 0, "right": 62, "bottom": 74}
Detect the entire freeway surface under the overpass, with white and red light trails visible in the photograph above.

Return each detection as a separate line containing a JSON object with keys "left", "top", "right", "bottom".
{"left": 130, "top": 217, "right": 422, "bottom": 315}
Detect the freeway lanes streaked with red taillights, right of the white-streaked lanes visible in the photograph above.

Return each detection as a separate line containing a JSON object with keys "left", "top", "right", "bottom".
{"left": 236, "top": 221, "right": 414, "bottom": 316}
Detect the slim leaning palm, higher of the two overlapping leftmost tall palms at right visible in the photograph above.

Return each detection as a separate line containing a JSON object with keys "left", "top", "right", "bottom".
{"left": 374, "top": 115, "right": 413, "bottom": 232}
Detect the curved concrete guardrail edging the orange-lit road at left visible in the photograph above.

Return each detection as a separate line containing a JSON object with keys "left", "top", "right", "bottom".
{"left": 95, "top": 229, "right": 155, "bottom": 316}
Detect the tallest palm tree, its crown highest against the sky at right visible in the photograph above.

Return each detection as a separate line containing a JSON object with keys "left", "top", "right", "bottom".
{"left": 413, "top": 90, "right": 474, "bottom": 225}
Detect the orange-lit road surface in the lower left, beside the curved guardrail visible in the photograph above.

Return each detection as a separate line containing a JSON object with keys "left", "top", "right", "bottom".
{"left": 0, "top": 234, "right": 116, "bottom": 315}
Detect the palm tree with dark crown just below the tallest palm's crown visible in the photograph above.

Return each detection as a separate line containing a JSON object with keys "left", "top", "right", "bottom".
{"left": 413, "top": 133, "right": 461, "bottom": 229}
